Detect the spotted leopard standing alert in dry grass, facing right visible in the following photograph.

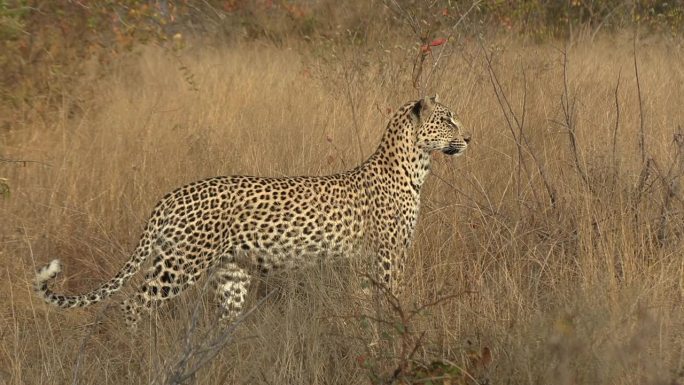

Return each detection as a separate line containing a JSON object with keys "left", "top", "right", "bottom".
{"left": 34, "top": 95, "right": 471, "bottom": 329}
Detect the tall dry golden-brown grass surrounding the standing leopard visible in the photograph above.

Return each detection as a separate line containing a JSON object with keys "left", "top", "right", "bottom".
{"left": 0, "top": 33, "right": 684, "bottom": 384}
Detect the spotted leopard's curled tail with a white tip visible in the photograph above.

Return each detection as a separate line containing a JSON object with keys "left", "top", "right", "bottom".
{"left": 33, "top": 232, "right": 151, "bottom": 308}
